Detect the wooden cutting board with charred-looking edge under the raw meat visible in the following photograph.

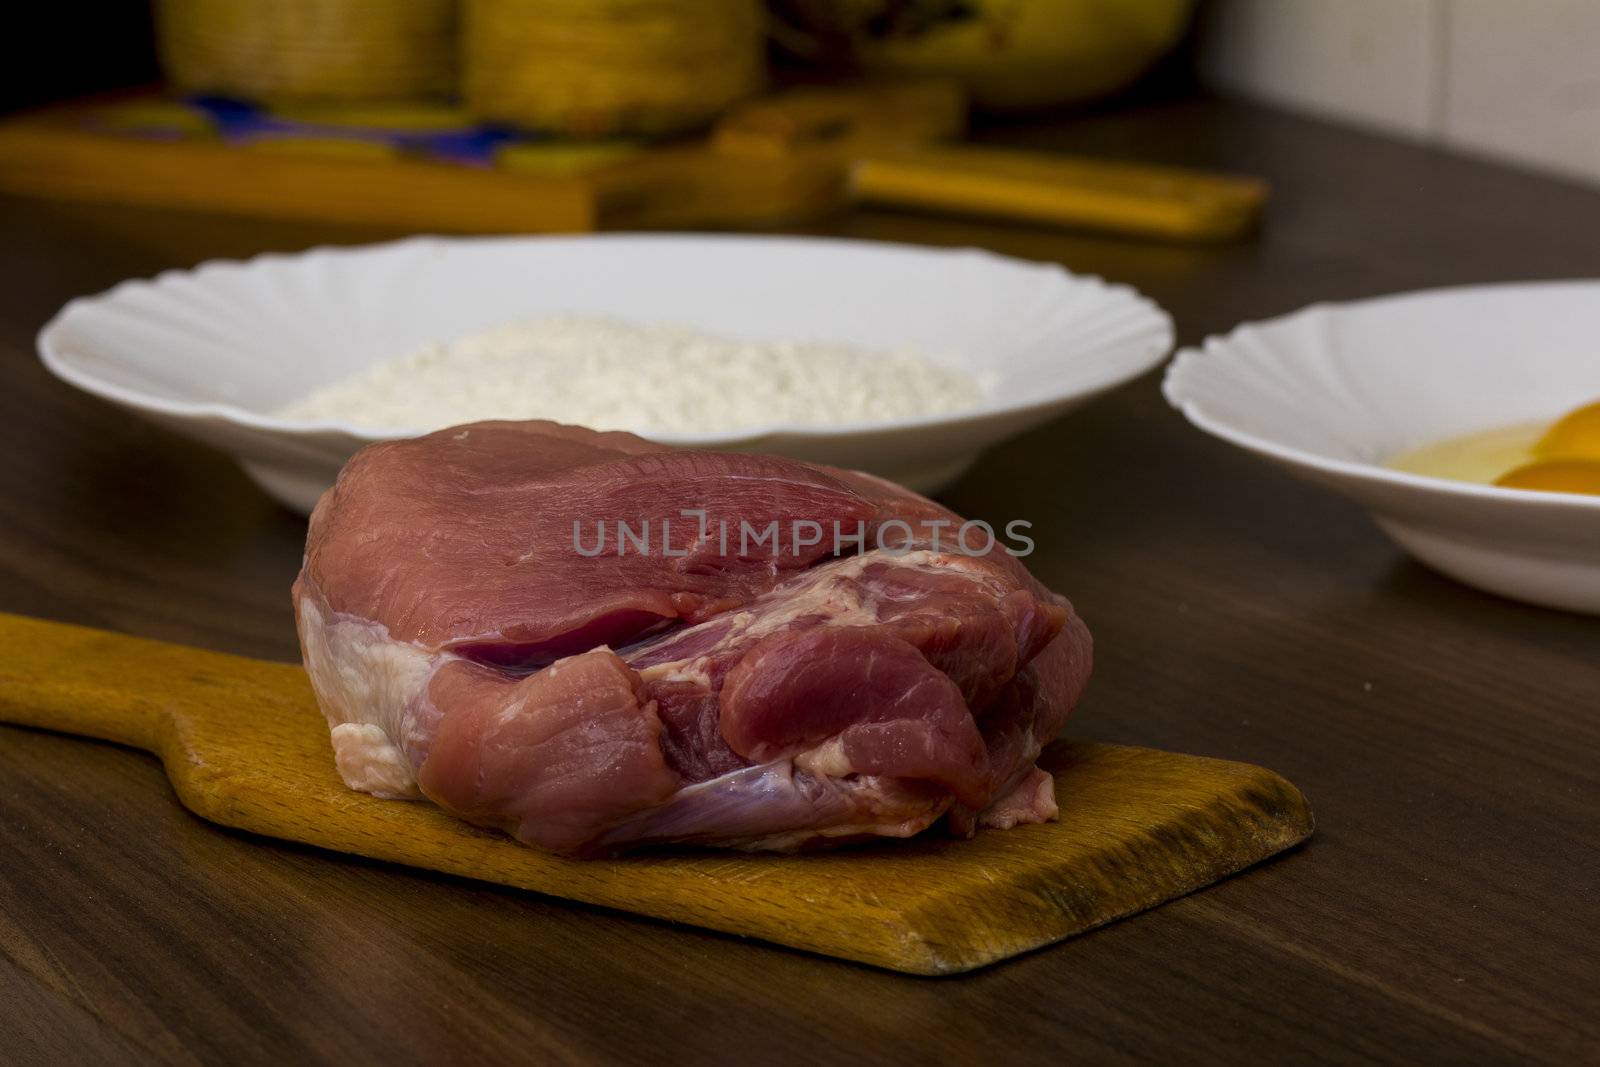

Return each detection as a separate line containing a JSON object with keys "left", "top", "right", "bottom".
{"left": 0, "top": 614, "right": 1312, "bottom": 974}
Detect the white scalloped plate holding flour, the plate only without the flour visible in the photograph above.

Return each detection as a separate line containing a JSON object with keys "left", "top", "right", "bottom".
{"left": 38, "top": 235, "right": 1173, "bottom": 512}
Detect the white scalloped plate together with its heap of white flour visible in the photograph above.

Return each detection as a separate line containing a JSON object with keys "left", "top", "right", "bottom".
{"left": 38, "top": 235, "right": 1173, "bottom": 512}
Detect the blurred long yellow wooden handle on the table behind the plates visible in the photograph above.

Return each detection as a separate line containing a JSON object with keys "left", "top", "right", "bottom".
{"left": 851, "top": 146, "right": 1267, "bottom": 240}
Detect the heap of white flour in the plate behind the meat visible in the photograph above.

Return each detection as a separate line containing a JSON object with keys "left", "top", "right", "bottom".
{"left": 278, "top": 315, "right": 986, "bottom": 434}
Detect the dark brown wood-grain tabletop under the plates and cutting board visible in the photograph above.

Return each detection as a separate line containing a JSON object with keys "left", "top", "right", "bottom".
{"left": 0, "top": 101, "right": 1600, "bottom": 1062}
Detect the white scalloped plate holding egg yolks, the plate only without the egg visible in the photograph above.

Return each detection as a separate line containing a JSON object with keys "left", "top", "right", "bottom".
{"left": 1163, "top": 282, "right": 1600, "bottom": 613}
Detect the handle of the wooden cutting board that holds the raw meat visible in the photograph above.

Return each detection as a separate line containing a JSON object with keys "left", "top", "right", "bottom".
{"left": 0, "top": 613, "right": 195, "bottom": 753}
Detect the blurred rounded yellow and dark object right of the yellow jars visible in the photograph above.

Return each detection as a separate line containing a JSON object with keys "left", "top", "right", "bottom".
{"left": 771, "top": 0, "right": 1194, "bottom": 110}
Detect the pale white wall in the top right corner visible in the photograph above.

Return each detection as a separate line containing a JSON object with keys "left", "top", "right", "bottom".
{"left": 1200, "top": 0, "right": 1600, "bottom": 182}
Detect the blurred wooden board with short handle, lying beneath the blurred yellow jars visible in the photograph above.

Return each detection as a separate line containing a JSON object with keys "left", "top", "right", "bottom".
{"left": 0, "top": 88, "right": 940, "bottom": 234}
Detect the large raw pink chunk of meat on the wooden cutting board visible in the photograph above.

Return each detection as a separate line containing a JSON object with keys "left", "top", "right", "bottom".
{"left": 294, "top": 422, "right": 1091, "bottom": 854}
